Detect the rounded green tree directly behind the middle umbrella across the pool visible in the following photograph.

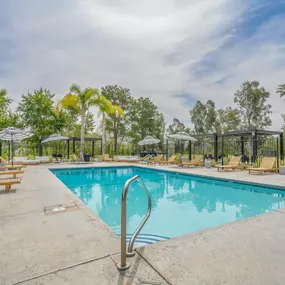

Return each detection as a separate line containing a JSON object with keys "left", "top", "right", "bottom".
{"left": 129, "top": 97, "right": 164, "bottom": 143}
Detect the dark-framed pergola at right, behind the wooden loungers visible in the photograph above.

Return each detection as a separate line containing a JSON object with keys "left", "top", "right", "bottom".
{"left": 189, "top": 129, "right": 284, "bottom": 163}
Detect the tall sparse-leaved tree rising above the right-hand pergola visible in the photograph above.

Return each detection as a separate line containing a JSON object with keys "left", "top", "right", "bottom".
{"left": 234, "top": 81, "right": 272, "bottom": 130}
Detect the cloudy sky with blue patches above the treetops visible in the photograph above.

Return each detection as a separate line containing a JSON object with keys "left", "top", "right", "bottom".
{"left": 0, "top": 0, "right": 285, "bottom": 130}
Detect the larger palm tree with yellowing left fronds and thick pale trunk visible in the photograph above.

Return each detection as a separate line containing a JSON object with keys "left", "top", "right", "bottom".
{"left": 61, "top": 84, "right": 100, "bottom": 161}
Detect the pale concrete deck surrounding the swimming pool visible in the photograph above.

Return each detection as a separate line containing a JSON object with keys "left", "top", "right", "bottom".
{"left": 0, "top": 163, "right": 285, "bottom": 285}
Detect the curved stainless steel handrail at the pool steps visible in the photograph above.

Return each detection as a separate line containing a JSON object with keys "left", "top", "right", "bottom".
{"left": 117, "top": 175, "right": 151, "bottom": 270}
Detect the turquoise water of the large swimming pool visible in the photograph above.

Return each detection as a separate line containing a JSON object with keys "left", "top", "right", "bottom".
{"left": 51, "top": 167, "right": 285, "bottom": 244}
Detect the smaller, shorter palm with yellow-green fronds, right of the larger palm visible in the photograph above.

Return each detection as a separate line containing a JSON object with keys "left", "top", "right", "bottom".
{"left": 97, "top": 95, "right": 124, "bottom": 154}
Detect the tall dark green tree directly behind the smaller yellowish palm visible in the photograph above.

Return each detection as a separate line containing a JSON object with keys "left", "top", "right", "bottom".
{"left": 101, "top": 85, "right": 133, "bottom": 153}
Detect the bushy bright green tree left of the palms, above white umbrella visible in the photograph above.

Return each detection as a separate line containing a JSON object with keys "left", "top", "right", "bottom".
{"left": 17, "top": 89, "right": 64, "bottom": 143}
